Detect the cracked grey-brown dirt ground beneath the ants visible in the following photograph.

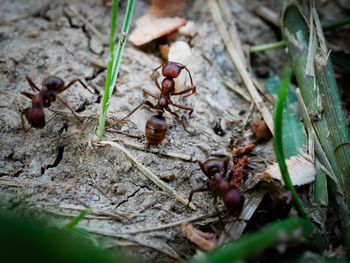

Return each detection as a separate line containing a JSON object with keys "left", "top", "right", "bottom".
{"left": 0, "top": 0, "right": 348, "bottom": 262}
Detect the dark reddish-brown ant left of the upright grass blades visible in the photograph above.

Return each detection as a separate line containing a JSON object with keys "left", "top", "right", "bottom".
{"left": 21, "top": 76, "right": 93, "bottom": 131}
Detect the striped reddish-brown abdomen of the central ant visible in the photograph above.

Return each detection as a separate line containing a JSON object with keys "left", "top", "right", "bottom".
{"left": 146, "top": 114, "right": 167, "bottom": 145}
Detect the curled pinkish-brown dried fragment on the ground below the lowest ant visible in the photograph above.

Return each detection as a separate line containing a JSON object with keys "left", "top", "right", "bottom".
{"left": 182, "top": 222, "right": 217, "bottom": 250}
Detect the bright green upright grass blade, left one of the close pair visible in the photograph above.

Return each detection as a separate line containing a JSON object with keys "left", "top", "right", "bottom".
{"left": 97, "top": 0, "right": 118, "bottom": 139}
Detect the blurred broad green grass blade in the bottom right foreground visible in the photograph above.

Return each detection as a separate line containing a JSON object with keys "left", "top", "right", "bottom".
{"left": 191, "top": 218, "right": 320, "bottom": 263}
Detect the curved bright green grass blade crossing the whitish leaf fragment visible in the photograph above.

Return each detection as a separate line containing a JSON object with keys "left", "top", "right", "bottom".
{"left": 273, "top": 68, "right": 306, "bottom": 219}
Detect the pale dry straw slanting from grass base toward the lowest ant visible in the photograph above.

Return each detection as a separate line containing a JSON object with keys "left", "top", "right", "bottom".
{"left": 94, "top": 141, "right": 196, "bottom": 210}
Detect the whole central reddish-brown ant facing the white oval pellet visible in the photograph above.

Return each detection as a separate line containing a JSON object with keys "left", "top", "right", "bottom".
{"left": 112, "top": 61, "right": 196, "bottom": 145}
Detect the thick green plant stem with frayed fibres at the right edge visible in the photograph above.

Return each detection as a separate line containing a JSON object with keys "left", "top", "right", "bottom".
{"left": 282, "top": 4, "right": 350, "bottom": 248}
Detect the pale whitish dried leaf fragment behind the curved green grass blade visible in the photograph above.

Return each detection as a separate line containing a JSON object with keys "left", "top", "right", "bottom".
{"left": 260, "top": 156, "right": 316, "bottom": 186}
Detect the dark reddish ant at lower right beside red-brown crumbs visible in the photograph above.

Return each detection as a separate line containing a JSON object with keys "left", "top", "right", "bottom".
{"left": 188, "top": 158, "right": 245, "bottom": 217}
